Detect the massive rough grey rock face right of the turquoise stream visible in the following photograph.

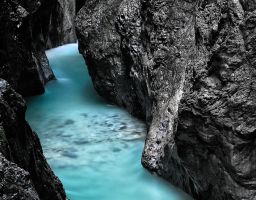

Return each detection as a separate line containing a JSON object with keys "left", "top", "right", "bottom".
{"left": 76, "top": 0, "right": 256, "bottom": 200}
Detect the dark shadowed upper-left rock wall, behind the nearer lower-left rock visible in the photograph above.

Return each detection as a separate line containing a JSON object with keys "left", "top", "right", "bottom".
{"left": 0, "top": 0, "right": 76, "bottom": 95}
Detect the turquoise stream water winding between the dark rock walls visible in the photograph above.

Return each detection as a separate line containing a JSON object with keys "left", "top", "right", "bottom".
{"left": 26, "top": 44, "right": 190, "bottom": 200}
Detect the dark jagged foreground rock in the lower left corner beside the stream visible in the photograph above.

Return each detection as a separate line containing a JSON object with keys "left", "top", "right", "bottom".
{"left": 0, "top": 79, "right": 66, "bottom": 200}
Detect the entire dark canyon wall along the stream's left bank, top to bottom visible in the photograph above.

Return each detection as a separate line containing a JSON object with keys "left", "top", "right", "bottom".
{"left": 0, "top": 0, "right": 80, "bottom": 200}
